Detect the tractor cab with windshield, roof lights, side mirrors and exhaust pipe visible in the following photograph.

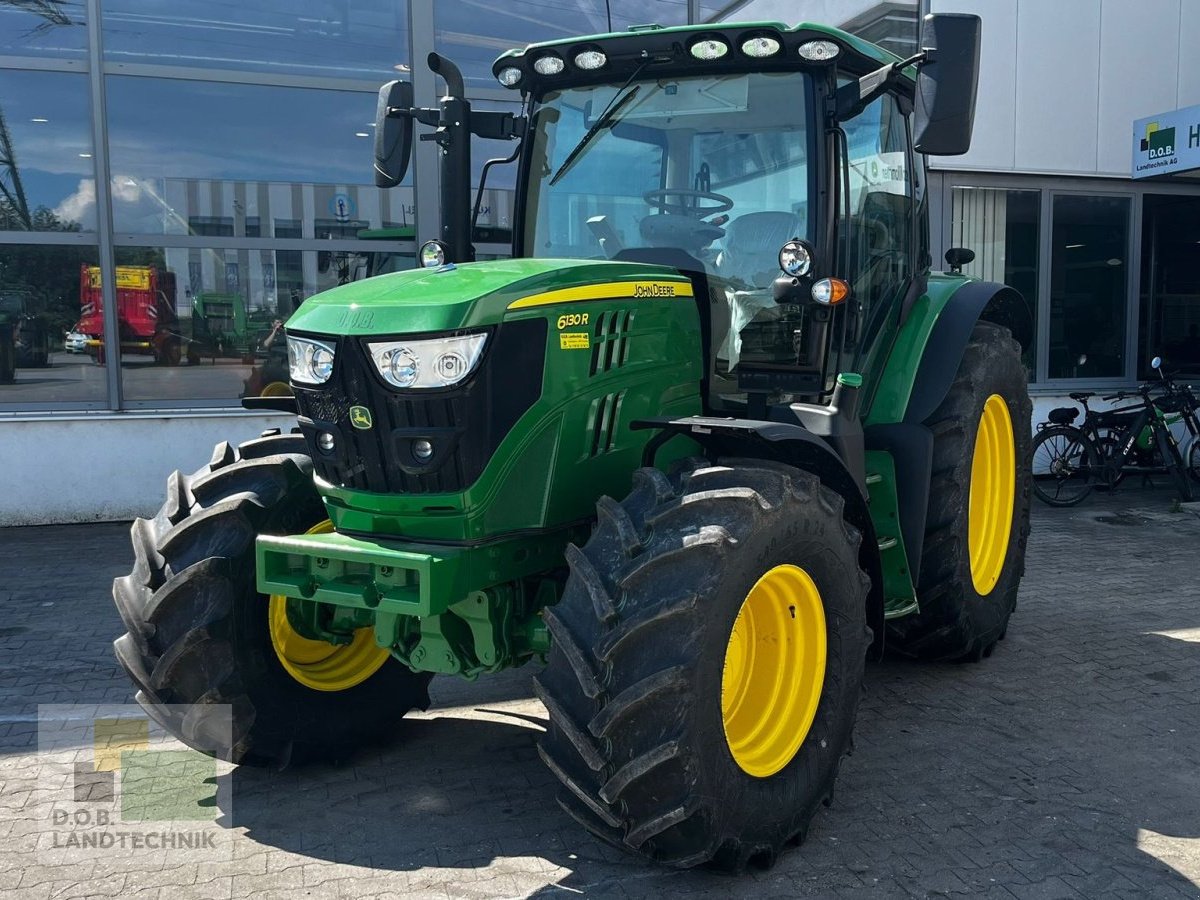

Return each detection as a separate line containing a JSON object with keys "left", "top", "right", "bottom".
{"left": 376, "top": 16, "right": 978, "bottom": 419}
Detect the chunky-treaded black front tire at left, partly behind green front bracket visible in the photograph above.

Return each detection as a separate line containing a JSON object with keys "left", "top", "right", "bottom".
{"left": 113, "top": 431, "right": 431, "bottom": 766}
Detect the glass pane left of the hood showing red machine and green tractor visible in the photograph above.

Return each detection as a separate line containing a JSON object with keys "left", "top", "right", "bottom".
{"left": 116, "top": 246, "right": 414, "bottom": 406}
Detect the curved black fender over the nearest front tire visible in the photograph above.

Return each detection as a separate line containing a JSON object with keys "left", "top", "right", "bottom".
{"left": 630, "top": 415, "right": 884, "bottom": 659}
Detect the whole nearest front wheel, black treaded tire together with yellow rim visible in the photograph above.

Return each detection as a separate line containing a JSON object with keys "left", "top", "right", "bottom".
{"left": 535, "top": 460, "right": 871, "bottom": 871}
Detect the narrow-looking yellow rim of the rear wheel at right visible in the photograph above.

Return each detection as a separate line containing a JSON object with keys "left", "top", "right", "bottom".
{"left": 967, "top": 394, "right": 1016, "bottom": 595}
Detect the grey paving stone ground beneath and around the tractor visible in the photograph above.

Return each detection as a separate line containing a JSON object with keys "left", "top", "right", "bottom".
{"left": 0, "top": 491, "right": 1200, "bottom": 900}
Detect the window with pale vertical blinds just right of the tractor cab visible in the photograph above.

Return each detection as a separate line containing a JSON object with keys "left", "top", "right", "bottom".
{"left": 935, "top": 186, "right": 1042, "bottom": 380}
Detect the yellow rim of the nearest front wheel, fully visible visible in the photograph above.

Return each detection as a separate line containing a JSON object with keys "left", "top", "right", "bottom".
{"left": 721, "top": 565, "right": 827, "bottom": 778}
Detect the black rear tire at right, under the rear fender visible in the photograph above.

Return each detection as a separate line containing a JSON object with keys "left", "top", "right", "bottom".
{"left": 889, "top": 322, "right": 1033, "bottom": 661}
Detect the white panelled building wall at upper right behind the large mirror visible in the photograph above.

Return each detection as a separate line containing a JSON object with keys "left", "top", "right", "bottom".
{"left": 930, "top": 0, "right": 1200, "bottom": 178}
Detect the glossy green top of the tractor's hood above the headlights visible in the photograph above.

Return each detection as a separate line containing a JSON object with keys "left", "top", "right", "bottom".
{"left": 288, "top": 259, "right": 691, "bottom": 337}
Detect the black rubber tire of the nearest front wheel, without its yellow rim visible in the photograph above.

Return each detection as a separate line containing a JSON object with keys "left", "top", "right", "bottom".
{"left": 534, "top": 458, "right": 870, "bottom": 869}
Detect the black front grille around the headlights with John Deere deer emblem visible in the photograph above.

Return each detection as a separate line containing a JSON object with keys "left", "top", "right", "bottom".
{"left": 295, "top": 319, "right": 546, "bottom": 493}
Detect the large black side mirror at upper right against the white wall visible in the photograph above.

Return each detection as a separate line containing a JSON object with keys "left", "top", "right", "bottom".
{"left": 913, "top": 13, "right": 980, "bottom": 156}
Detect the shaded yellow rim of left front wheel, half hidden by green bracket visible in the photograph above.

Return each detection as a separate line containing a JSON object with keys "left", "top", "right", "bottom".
{"left": 268, "top": 518, "right": 391, "bottom": 691}
